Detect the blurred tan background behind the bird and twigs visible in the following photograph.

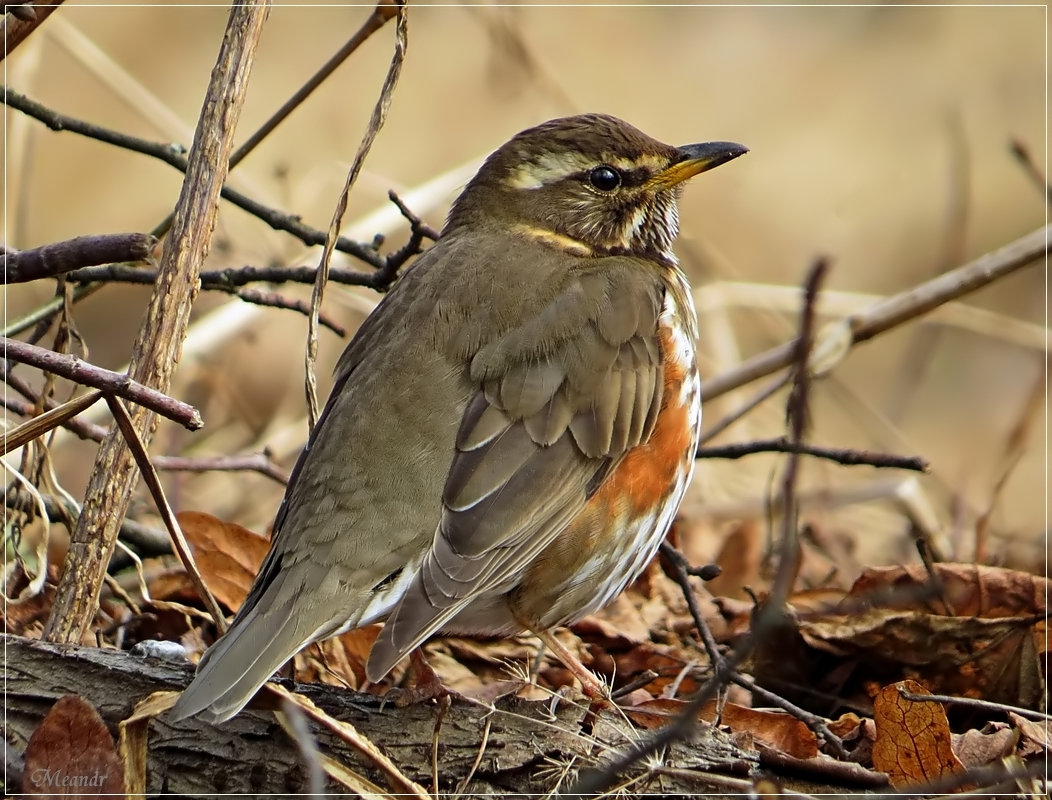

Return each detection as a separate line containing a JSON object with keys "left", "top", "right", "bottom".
{"left": 4, "top": 0, "right": 1047, "bottom": 582}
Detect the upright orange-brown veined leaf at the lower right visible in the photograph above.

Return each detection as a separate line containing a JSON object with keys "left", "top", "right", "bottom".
{"left": 873, "top": 680, "right": 965, "bottom": 788}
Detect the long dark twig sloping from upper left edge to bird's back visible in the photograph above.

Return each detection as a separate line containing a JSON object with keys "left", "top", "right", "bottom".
{"left": 2, "top": 87, "right": 384, "bottom": 269}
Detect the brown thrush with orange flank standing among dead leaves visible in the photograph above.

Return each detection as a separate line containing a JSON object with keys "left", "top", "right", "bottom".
{"left": 173, "top": 114, "right": 747, "bottom": 722}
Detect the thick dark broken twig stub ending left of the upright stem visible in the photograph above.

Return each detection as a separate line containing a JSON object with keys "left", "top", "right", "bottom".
{"left": 3, "top": 234, "right": 157, "bottom": 283}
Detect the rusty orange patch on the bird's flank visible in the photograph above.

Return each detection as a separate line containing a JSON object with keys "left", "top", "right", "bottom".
{"left": 588, "top": 327, "right": 693, "bottom": 515}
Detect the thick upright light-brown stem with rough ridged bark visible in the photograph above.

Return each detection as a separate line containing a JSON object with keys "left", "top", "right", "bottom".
{"left": 44, "top": 2, "right": 269, "bottom": 642}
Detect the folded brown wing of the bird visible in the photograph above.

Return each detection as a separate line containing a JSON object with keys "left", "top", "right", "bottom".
{"left": 367, "top": 258, "right": 664, "bottom": 680}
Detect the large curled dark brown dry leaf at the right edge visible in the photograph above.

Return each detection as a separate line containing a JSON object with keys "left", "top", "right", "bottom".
{"left": 754, "top": 564, "right": 1052, "bottom": 721}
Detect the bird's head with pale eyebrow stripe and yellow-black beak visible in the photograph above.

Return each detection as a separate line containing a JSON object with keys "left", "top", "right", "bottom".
{"left": 445, "top": 114, "right": 747, "bottom": 259}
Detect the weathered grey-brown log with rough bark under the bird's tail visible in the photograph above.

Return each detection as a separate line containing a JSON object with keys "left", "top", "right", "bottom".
{"left": 8, "top": 636, "right": 757, "bottom": 798}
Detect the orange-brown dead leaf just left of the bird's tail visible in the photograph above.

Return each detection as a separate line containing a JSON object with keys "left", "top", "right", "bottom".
{"left": 177, "top": 512, "right": 270, "bottom": 611}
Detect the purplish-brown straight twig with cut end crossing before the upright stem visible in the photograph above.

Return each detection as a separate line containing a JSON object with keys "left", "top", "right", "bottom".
{"left": 0, "top": 337, "right": 204, "bottom": 431}
